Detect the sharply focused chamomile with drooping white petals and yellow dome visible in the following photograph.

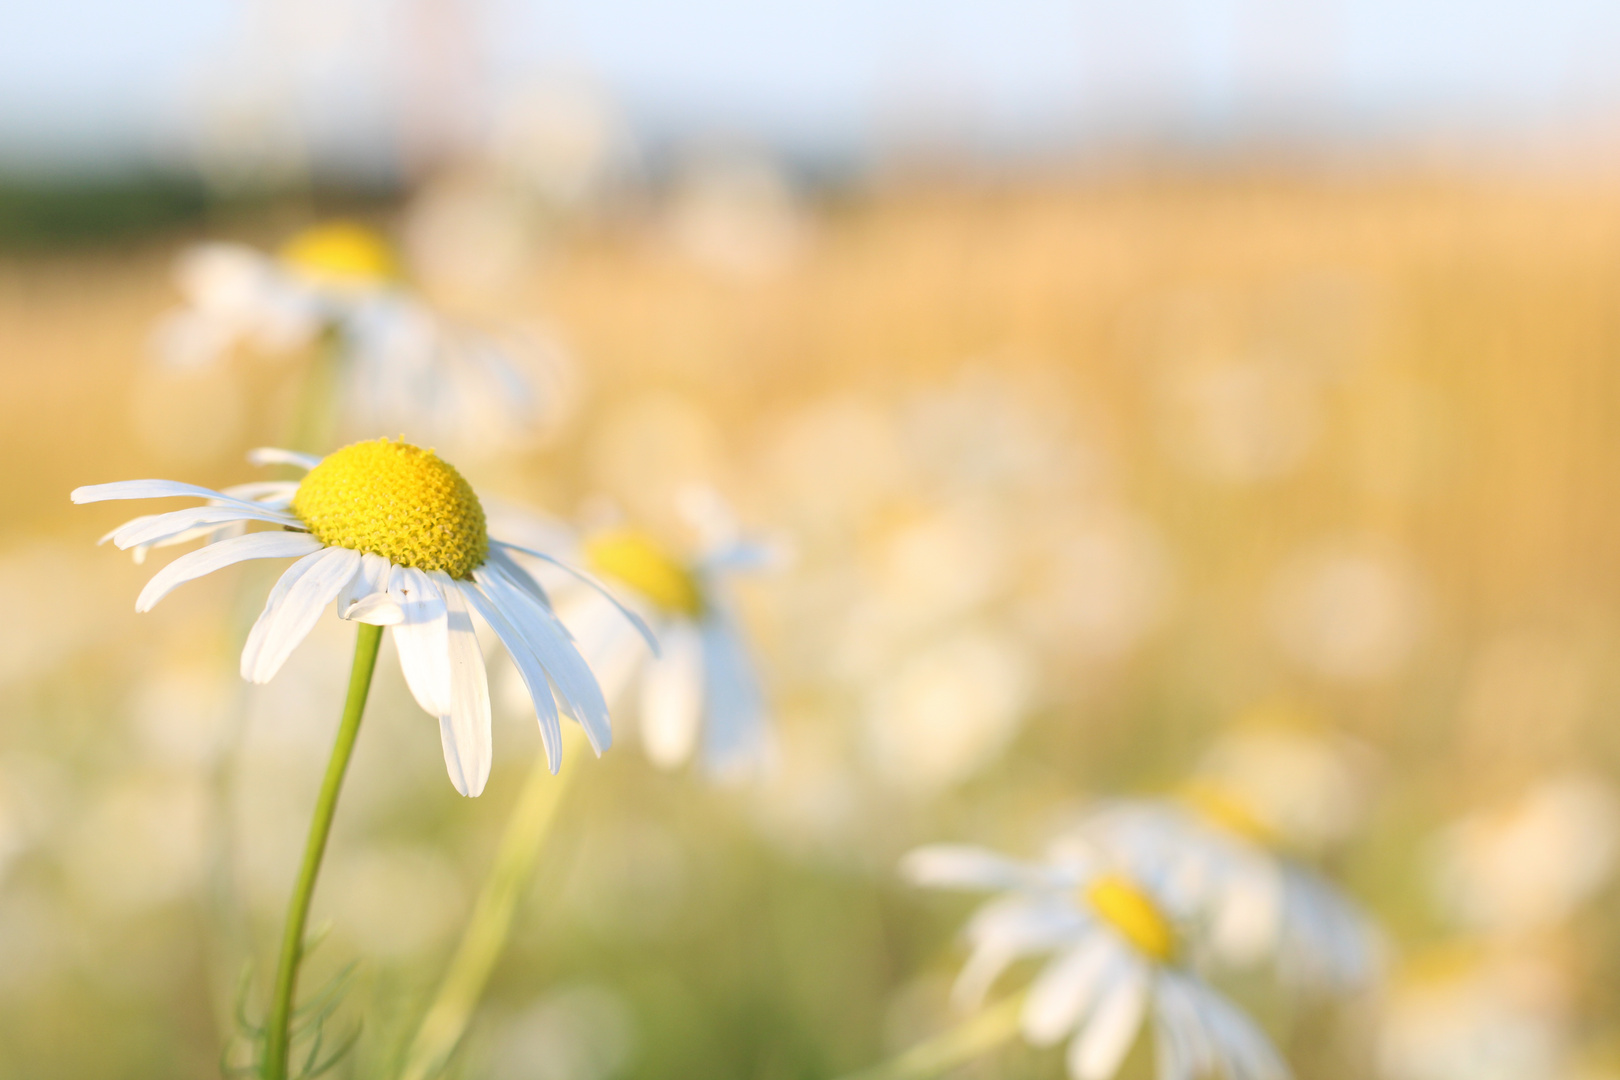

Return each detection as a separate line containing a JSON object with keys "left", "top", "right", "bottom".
{"left": 73, "top": 439, "right": 644, "bottom": 795}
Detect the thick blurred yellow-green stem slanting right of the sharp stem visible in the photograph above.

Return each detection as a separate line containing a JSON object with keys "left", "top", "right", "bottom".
{"left": 400, "top": 724, "right": 585, "bottom": 1080}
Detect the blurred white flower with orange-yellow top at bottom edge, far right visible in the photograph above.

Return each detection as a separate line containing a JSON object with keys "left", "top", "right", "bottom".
{"left": 1379, "top": 952, "right": 1570, "bottom": 1080}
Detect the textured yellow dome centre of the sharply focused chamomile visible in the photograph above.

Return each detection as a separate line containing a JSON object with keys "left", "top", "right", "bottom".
{"left": 292, "top": 439, "right": 489, "bottom": 578}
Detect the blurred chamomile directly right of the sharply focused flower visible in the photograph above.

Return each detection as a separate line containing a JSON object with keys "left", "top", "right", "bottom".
{"left": 517, "top": 491, "right": 779, "bottom": 776}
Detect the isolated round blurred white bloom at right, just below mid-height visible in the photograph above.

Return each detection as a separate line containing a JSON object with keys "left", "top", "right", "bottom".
{"left": 1267, "top": 544, "right": 1429, "bottom": 680}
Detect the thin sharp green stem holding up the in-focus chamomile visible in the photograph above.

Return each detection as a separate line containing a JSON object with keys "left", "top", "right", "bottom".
{"left": 264, "top": 623, "right": 382, "bottom": 1080}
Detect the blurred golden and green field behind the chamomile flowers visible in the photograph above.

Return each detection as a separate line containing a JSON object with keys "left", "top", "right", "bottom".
{"left": 0, "top": 172, "right": 1620, "bottom": 1080}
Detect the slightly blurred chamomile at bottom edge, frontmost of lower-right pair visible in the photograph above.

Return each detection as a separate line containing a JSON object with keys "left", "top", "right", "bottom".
{"left": 902, "top": 839, "right": 1288, "bottom": 1080}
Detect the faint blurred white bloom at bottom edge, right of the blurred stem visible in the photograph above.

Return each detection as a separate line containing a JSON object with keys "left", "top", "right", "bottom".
{"left": 484, "top": 983, "right": 637, "bottom": 1080}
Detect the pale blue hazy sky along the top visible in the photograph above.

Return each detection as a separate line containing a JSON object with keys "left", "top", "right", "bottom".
{"left": 0, "top": 0, "right": 1620, "bottom": 170}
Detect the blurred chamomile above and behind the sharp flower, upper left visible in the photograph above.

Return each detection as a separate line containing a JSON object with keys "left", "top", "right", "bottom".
{"left": 154, "top": 222, "right": 561, "bottom": 445}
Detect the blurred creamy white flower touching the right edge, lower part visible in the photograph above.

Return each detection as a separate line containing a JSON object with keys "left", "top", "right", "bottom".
{"left": 1435, "top": 772, "right": 1620, "bottom": 934}
